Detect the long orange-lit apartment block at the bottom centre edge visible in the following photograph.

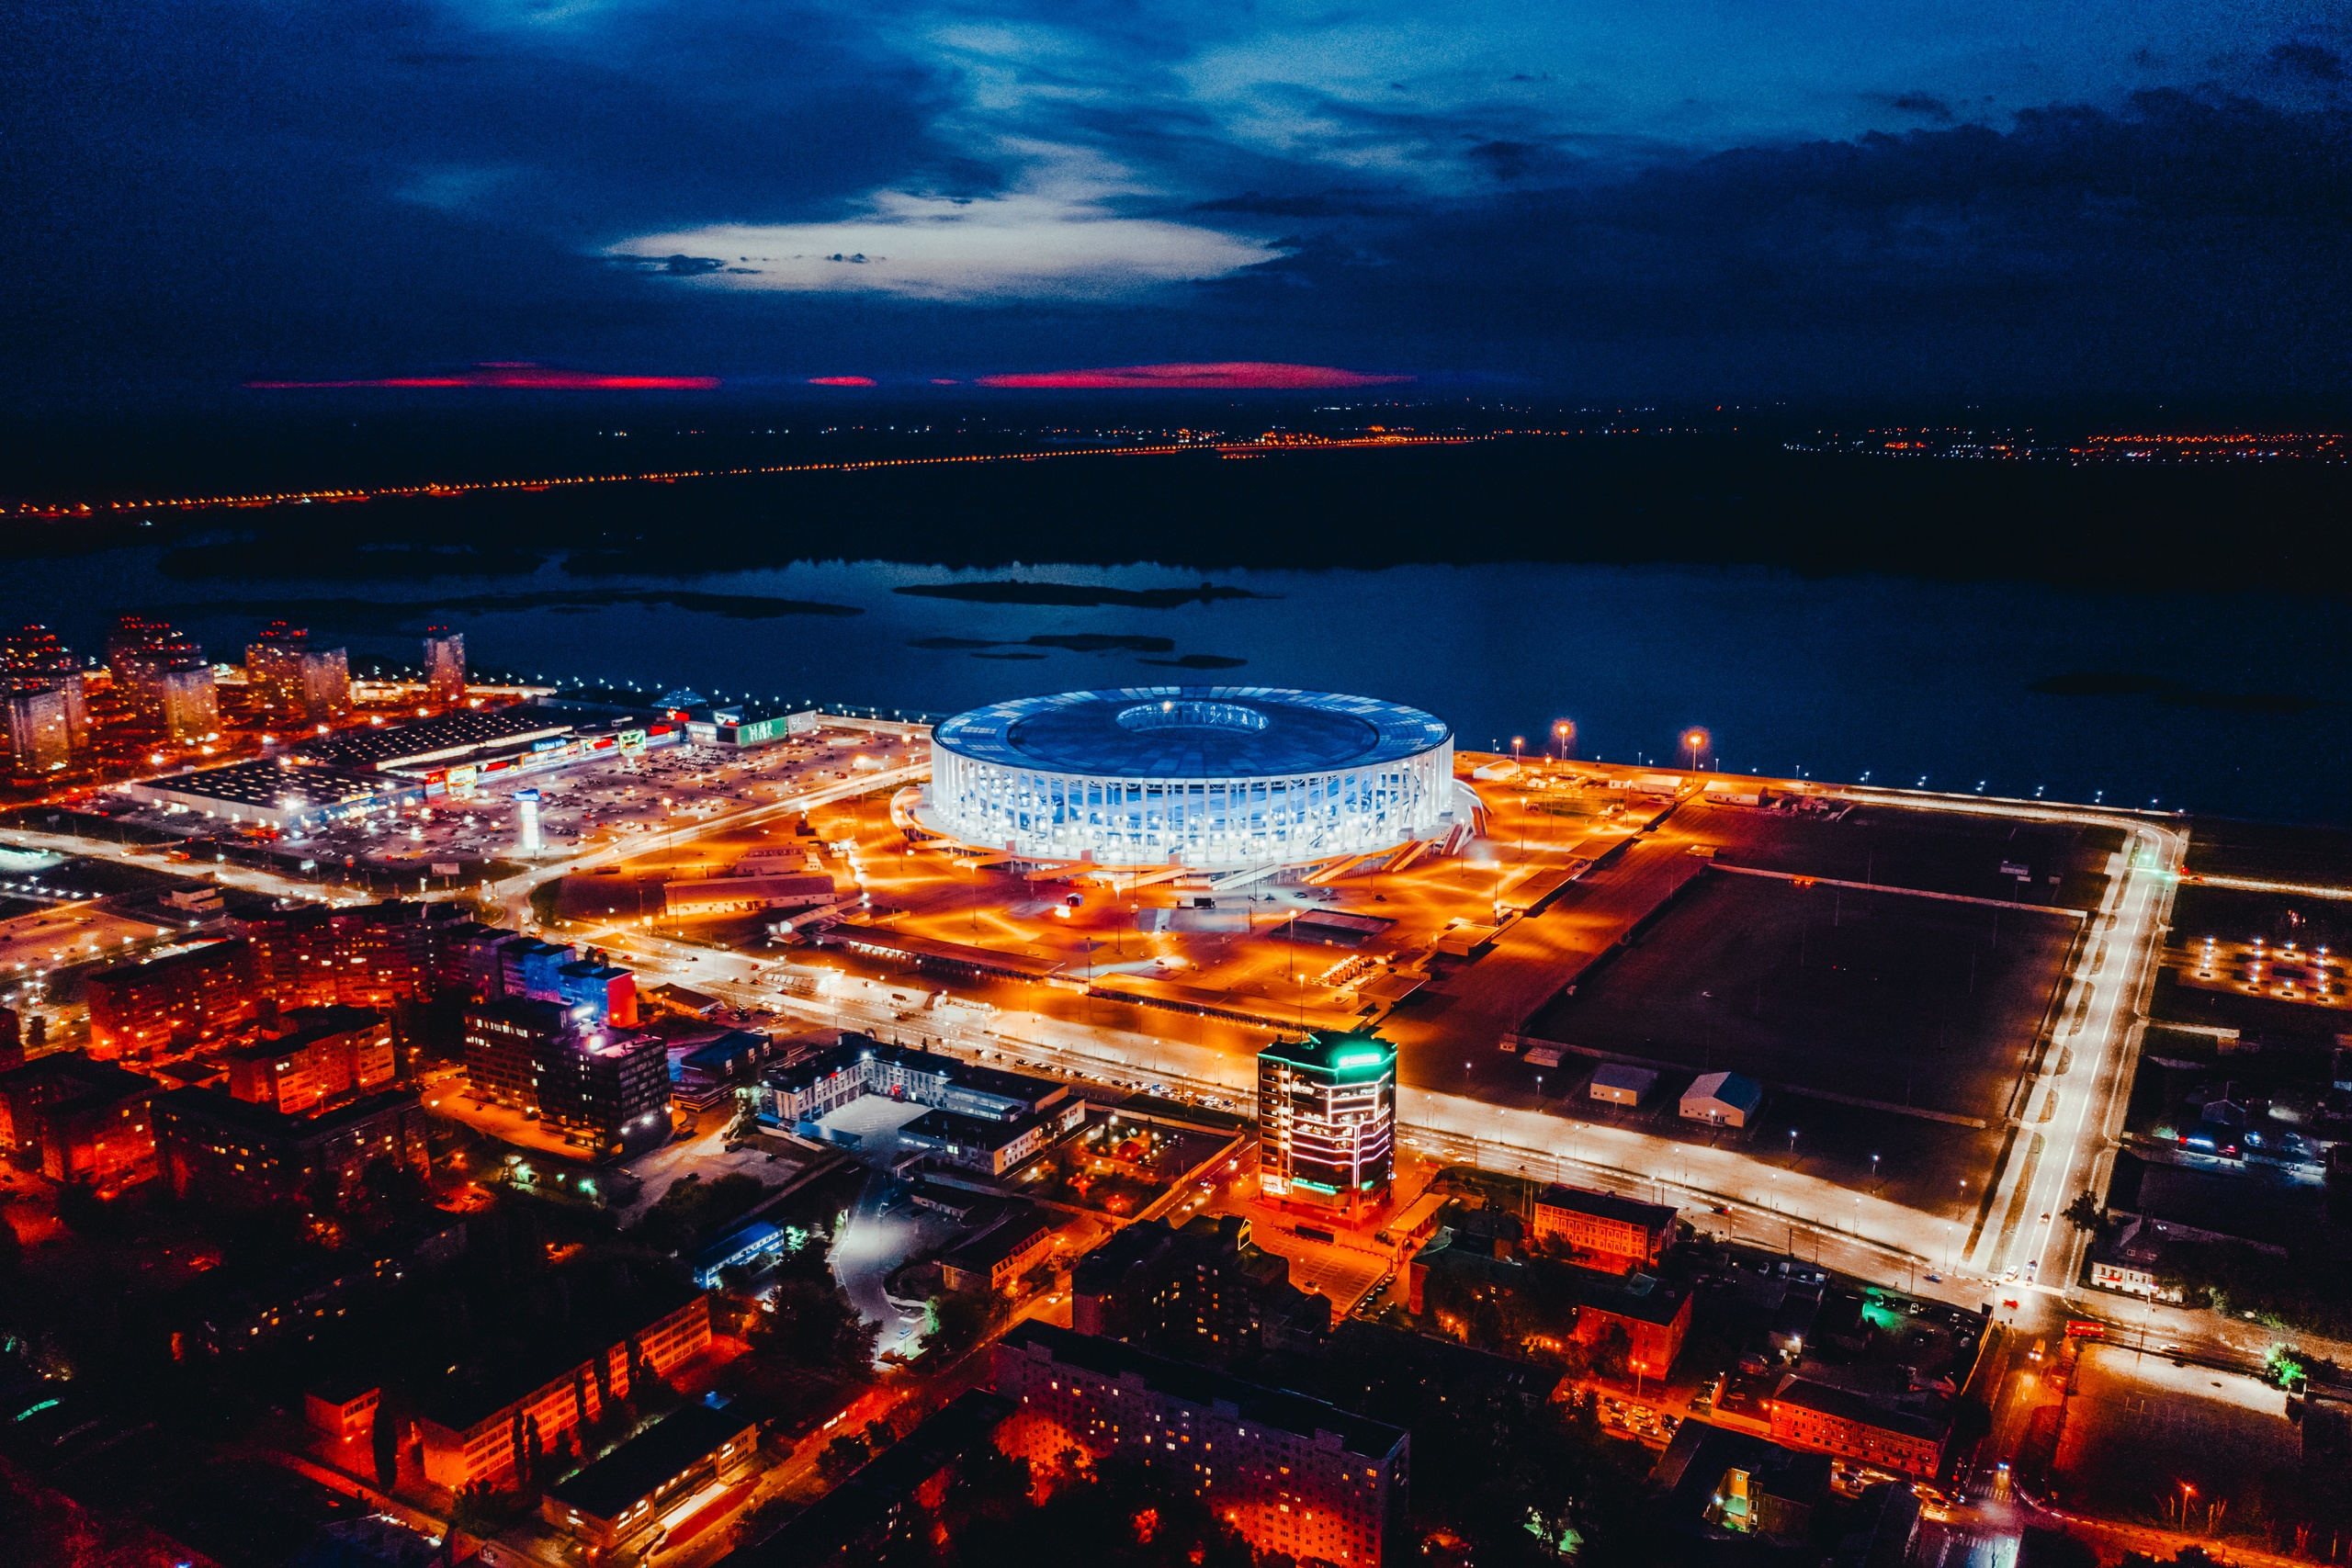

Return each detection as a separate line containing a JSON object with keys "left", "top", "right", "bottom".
{"left": 995, "top": 1319, "right": 1411, "bottom": 1568}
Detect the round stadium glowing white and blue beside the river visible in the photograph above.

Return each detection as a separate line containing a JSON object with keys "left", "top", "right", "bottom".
{"left": 922, "top": 686, "right": 1453, "bottom": 867}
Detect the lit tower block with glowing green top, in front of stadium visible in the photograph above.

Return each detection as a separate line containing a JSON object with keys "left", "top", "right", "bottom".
{"left": 1259, "top": 1034, "right": 1397, "bottom": 1213}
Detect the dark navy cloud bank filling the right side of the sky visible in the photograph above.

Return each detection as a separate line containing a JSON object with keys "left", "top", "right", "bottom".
{"left": 1218, "top": 92, "right": 2352, "bottom": 392}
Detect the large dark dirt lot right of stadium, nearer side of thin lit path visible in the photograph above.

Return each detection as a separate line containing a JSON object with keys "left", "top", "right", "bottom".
{"left": 1526, "top": 872, "right": 2076, "bottom": 1122}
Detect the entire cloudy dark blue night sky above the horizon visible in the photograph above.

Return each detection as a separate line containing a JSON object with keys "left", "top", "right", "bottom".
{"left": 0, "top": 0, "right": 2352, "bottom": 407}
